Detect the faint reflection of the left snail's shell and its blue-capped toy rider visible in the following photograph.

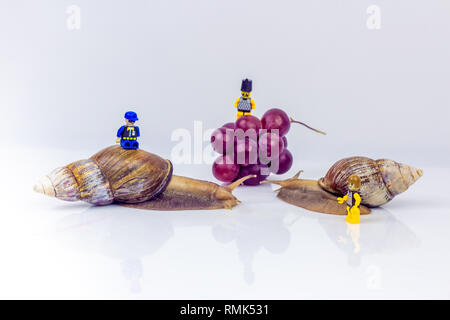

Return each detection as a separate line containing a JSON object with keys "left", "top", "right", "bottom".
{"left": 57, "top": 206, "right": 174, "bottom": 293}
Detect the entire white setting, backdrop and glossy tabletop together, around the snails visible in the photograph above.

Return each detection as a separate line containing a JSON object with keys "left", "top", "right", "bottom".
{"left": 0, "top": 0, "right": 450, "bottom": 298}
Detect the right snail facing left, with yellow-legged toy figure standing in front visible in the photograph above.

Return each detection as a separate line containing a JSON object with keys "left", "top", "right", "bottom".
{"left": 262, "top": 157, "right": 423, "bottom": 215}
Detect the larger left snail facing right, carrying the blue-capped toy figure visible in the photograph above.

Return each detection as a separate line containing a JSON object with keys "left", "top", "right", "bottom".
{"left": 34, "top": 146, "right": 253, "bottom": 210}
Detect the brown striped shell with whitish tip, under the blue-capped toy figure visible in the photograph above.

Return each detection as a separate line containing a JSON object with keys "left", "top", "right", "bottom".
{"left": 34, "top": 146, "right": 172, "bottom": 205}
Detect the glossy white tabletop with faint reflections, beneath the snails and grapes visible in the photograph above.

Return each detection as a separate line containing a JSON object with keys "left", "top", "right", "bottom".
{"left": 0, "top": 150, "right": 450, "bottom": 299}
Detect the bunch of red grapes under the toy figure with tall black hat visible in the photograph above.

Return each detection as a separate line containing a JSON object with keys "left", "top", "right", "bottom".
{"left": 211, "top": 108, "right": 293, "bottom": 186}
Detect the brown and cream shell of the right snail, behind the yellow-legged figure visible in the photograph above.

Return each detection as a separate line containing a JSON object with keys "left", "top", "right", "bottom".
{"left": 319, "top": 157, "right": 423, "bottom": 207}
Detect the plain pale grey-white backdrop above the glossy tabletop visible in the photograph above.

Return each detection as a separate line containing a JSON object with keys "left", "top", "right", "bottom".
{"left": 0, "top": 0, "right": 450, "bottom": 169}
